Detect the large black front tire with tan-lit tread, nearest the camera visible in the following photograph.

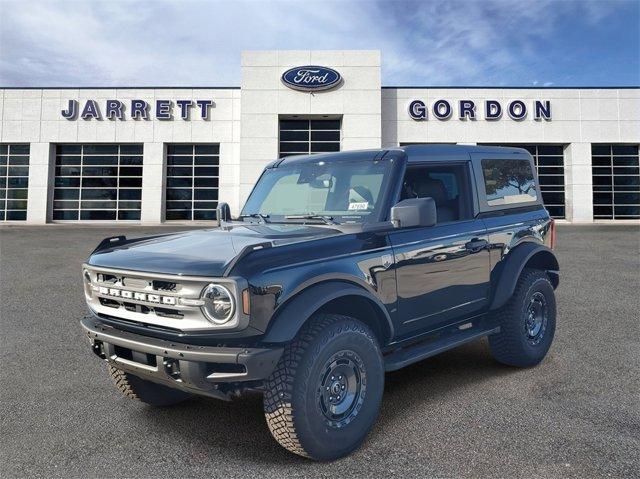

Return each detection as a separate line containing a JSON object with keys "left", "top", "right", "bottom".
{"left": 264, "top": 314, "right": 384, "bottom": 461}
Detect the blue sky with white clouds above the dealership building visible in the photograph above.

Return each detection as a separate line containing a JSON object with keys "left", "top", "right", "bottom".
{"left": 0, "top": 0, "right": 640, "bottom": 86}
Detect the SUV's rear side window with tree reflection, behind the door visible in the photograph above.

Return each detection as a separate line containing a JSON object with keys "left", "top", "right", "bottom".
{"left": 482, "top": 160, "right": 538, "bottom": 206}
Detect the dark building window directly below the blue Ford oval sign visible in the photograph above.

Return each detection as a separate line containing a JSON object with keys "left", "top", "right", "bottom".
{"left": 280, "top": 119, "right": 340, "bottom": 158}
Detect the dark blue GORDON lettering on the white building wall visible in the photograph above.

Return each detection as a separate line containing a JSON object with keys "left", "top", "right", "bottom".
{"left": 409, "top": 100, "right": 551, "bottom": 121}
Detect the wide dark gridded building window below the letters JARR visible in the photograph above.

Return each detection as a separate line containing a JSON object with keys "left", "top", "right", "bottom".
{"left": 53, "top": 144, "right": 142, "bottom": 221}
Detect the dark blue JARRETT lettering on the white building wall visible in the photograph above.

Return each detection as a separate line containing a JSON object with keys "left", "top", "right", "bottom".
{"left": 60, "top": 100, "right": 214, "bottom": 120}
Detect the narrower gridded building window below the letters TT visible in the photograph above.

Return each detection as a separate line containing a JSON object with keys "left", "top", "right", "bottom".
{"left": 165, "top": 144, "right": 220, "bottom": 221}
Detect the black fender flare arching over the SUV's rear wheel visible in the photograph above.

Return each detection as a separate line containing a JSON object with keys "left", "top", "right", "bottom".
{"left": 489, "top": 242, "right": 560, "bottom": 310}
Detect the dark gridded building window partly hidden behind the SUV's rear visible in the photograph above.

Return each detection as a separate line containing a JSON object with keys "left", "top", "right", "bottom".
{"left": 480, "top": 143, "right": 565, "bottom": 219}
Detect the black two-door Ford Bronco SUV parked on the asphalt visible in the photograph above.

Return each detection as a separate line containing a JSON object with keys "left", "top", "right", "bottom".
{"left": 82, "top": 145, "right": 559, "bottom": 460}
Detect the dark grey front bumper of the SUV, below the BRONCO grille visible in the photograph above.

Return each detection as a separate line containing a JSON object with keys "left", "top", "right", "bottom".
{"left": 80, "top": 317, "right": 283, "bottom": 399}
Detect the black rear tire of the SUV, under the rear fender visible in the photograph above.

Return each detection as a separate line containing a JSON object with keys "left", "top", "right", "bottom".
{"left": 489, "top": 268, "right": 556, "bottom": 368}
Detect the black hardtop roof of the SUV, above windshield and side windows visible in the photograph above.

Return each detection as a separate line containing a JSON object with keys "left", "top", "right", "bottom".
{"left": 274, "top": 143, "right": 529, "bottom": 168}
